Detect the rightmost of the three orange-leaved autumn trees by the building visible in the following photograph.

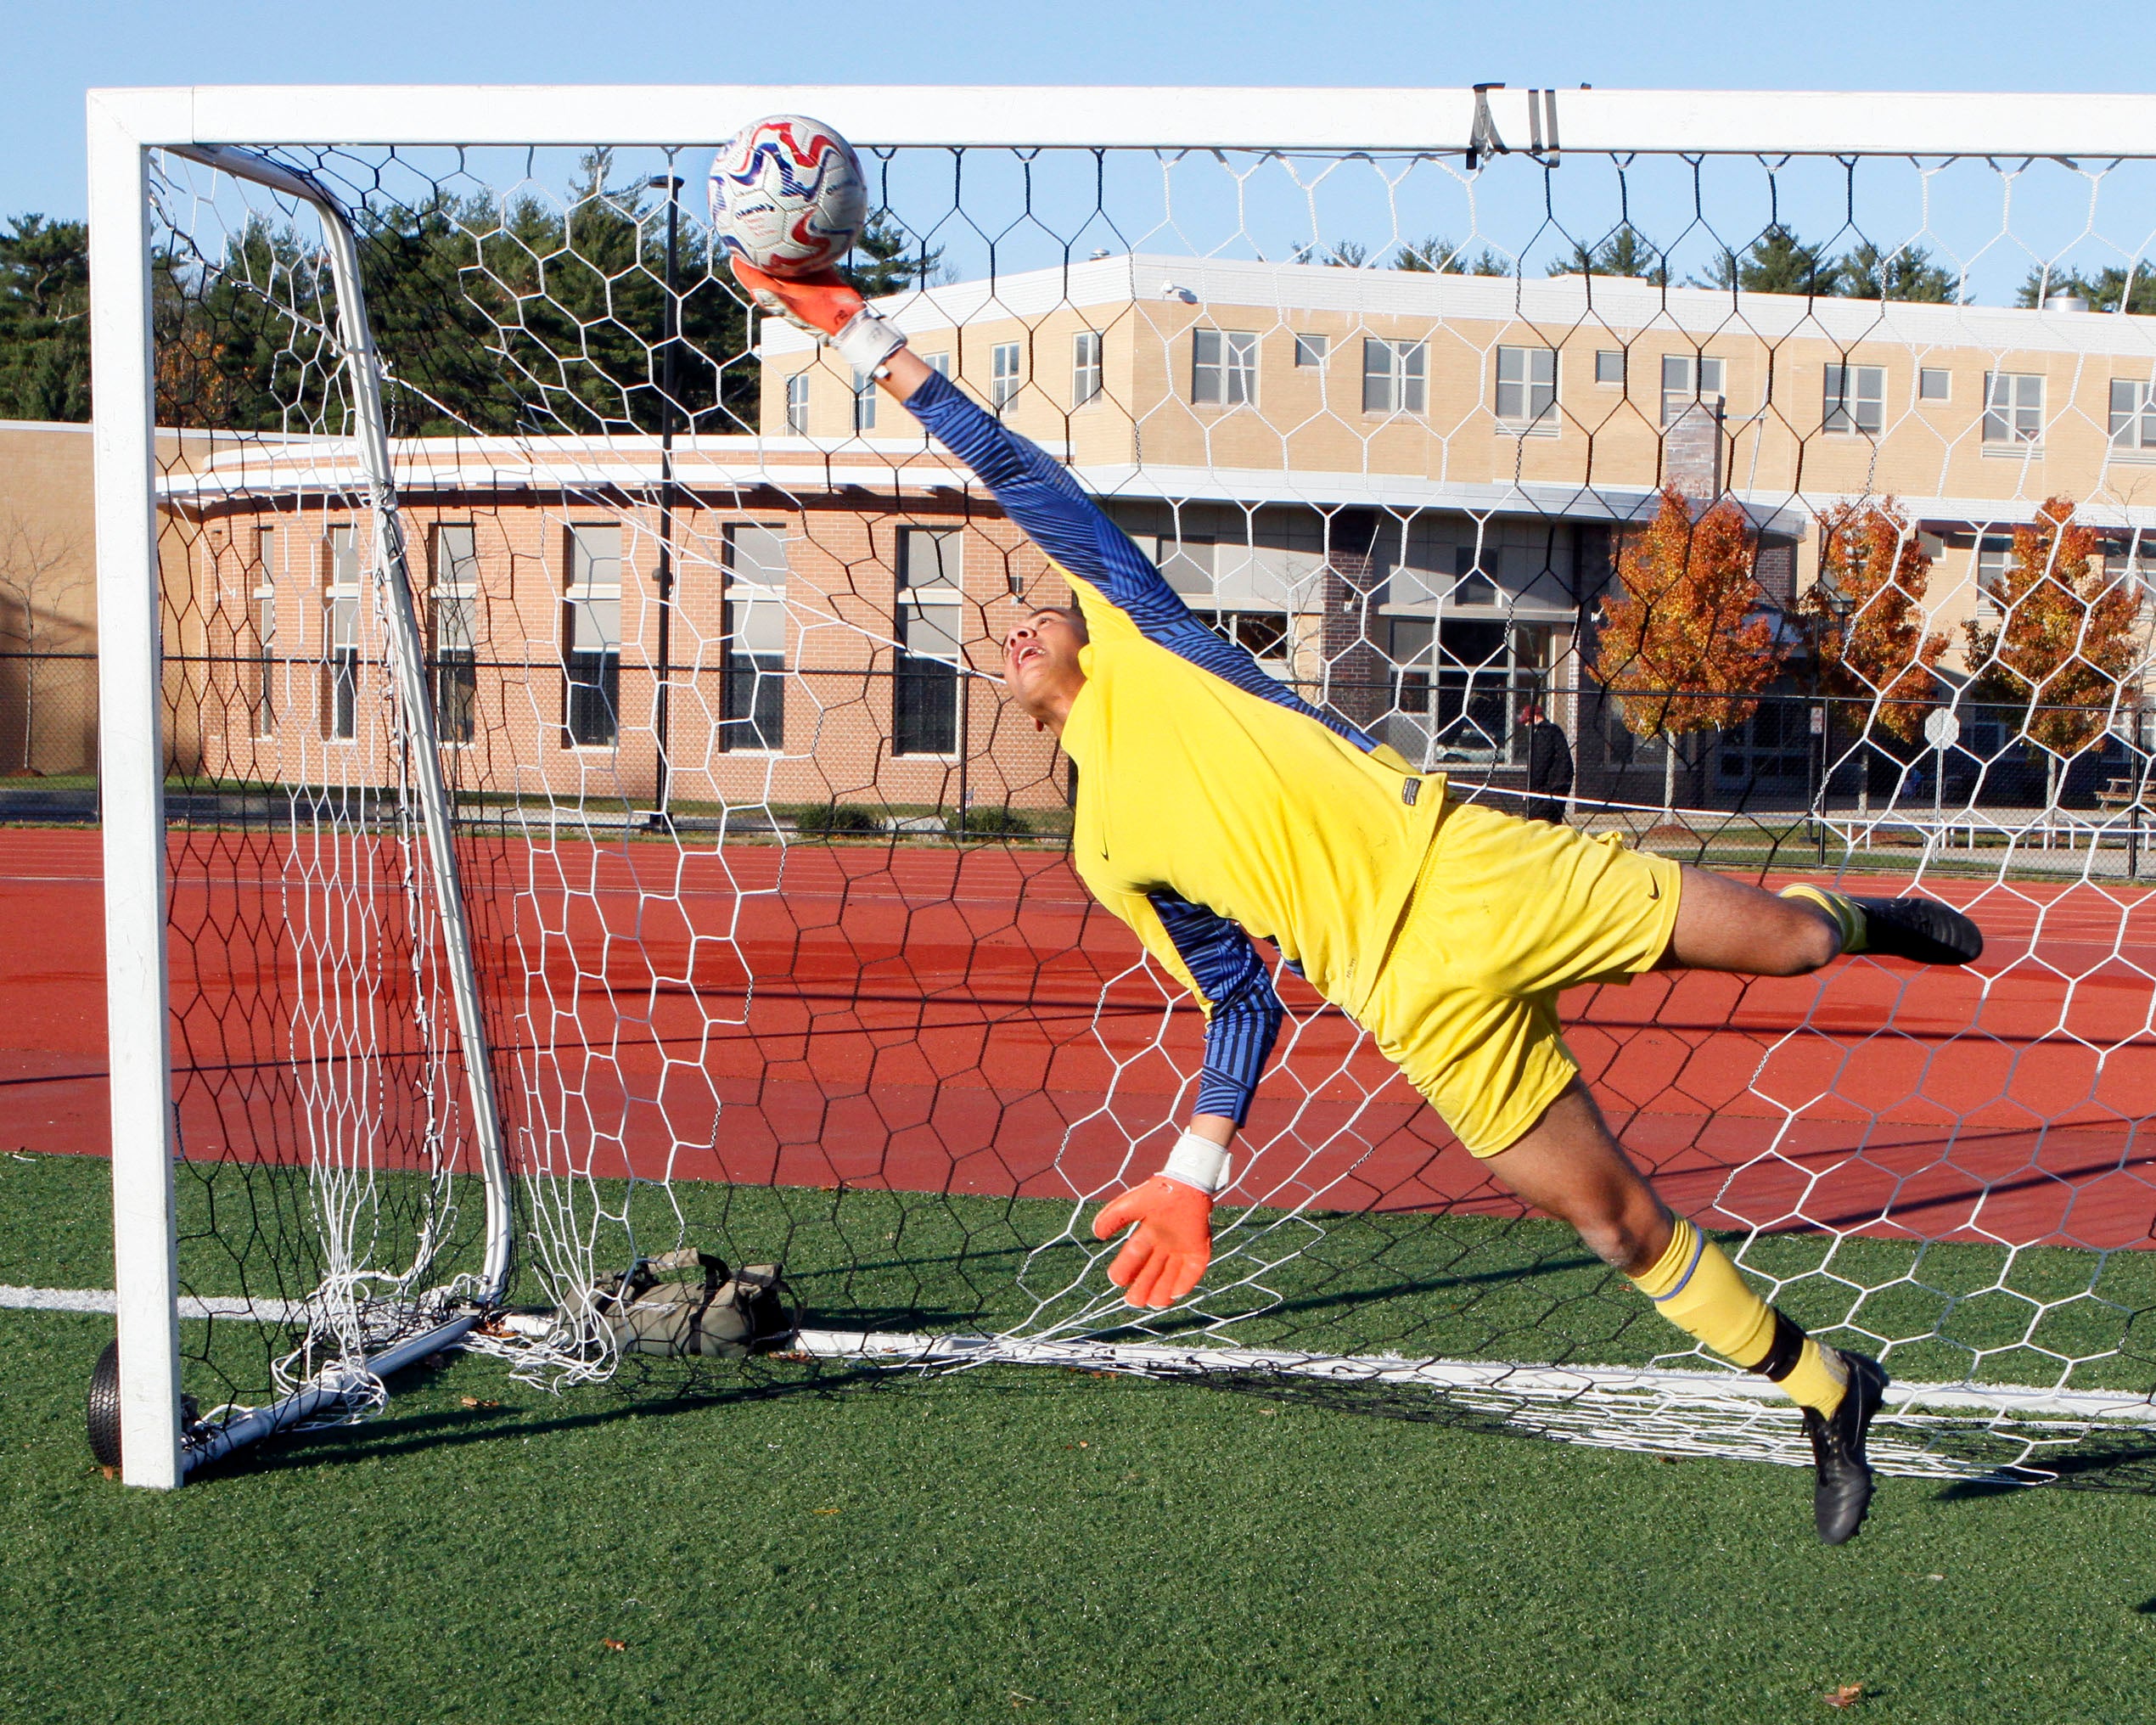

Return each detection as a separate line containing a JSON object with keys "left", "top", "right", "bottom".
{"left": 1966, "top": 498, "right": 2141, "bottom": 804}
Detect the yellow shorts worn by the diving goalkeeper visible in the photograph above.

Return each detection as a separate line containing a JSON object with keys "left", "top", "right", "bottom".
{"left": 1361, "top": 802, "right": 1682, "bottom": 1155}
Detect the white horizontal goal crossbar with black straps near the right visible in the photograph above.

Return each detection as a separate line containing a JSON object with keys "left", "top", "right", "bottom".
{"left": 88, "top": 84, "right": 2156, "bottom": 157}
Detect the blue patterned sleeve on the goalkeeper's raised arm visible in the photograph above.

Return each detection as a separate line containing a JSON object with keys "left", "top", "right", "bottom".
{"left": 906, "top": 373, "right": 1378, "bottom": 750}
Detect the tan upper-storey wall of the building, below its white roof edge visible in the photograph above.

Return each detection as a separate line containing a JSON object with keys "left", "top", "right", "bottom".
{"left": 766, "top": 259, "right": 2156, "bottom": 685}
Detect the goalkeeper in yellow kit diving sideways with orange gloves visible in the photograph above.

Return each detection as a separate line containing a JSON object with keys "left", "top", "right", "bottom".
{"left": 735, "top": 261, "right": 1984, "bottom": 1544}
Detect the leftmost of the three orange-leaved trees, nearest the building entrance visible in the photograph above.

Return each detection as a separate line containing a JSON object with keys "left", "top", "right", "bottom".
{"left": 1596, "top": 486, "right": 1783, "bottom": 819}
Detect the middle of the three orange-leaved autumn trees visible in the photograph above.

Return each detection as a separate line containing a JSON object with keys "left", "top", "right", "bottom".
{"left": 1796, "top": 498, "right": 1947, "bottom": 811}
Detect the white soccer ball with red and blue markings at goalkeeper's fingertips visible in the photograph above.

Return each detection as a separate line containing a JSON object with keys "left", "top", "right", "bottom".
{"left": 711, "top": 115, "right": 869, "bottom": 276}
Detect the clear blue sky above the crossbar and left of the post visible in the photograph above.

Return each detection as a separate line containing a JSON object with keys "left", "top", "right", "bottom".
{"left": 12, "top": 0, "right": 2156, "bottom": 216}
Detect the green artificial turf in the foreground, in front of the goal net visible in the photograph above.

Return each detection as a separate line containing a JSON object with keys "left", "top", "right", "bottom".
{"left": 0, "top": 1313, "right": 2156, "bottom": 1725}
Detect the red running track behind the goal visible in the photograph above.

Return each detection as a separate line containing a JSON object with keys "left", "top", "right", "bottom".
{"left": 12, "top": 830, "right": 2156, "bottom": 1246}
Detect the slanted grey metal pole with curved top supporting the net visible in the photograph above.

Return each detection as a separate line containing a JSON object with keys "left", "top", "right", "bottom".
{"left": 171, "top": 144, "right": 515, "bottom": 1301}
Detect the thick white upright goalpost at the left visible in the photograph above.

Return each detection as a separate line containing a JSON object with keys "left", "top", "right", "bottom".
{"left": 88, "top": 93, "right": 181, "bottom": 1488}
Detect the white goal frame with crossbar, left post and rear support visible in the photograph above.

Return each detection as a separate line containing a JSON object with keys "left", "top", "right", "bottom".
{"left": 88, "top": 87, "right": 2156, "bottom": 1488}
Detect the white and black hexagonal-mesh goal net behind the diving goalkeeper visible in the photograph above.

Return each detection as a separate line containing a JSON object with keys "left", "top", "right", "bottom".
{"left": 99, "top": 91, "right": 2156, "bottom": 1479}
